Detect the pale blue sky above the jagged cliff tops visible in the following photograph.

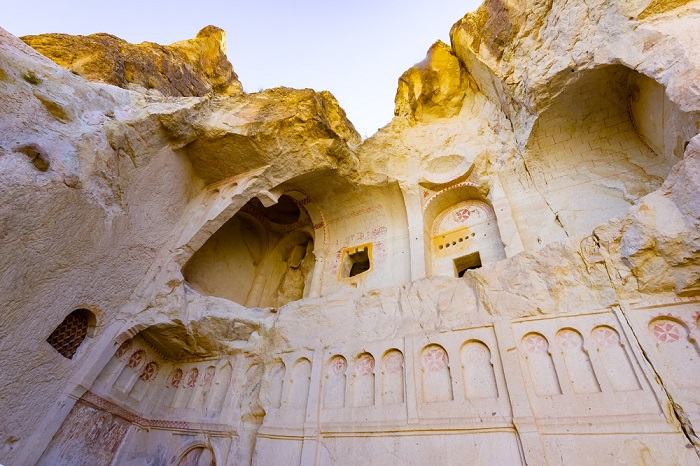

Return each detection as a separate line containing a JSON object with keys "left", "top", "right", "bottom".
{"left": 5, "top": 0, "right": 481, "bottom": 136}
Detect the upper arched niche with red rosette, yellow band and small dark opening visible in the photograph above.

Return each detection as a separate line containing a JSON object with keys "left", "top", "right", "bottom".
{"left": 424, "top": 184, "right": 506, "bottom": 277}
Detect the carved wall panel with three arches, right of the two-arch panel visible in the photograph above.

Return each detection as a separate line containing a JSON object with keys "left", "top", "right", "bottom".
{"left": 513, "top": 311, "right": 665, "bottom": 430}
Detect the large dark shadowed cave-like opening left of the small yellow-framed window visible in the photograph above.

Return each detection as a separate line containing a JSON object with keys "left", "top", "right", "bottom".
{"left": 183, "top": 193, "right": 315, "bottom": 307}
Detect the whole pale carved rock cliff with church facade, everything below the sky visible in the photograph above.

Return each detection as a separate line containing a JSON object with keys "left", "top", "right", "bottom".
{"left": 0, "top": 0, "right": 700, "bottom": 465}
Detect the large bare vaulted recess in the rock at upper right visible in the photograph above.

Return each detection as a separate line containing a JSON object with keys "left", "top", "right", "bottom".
{"left": 516, "top": 65, "right": 700, "bottom": 249}
